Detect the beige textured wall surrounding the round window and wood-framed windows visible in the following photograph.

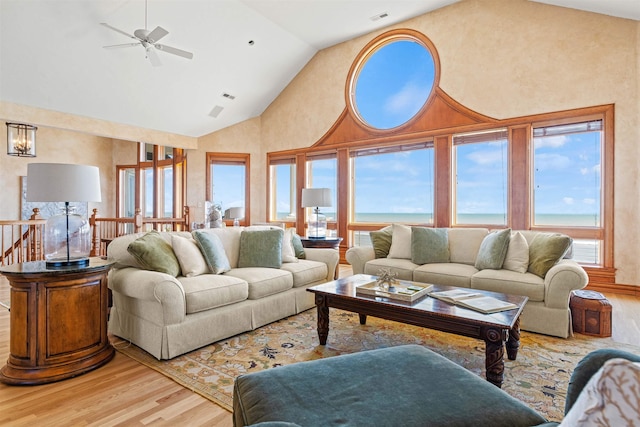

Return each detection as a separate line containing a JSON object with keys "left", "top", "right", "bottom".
{"left": 0, "top": 0, "right": 640, "bottom": 284}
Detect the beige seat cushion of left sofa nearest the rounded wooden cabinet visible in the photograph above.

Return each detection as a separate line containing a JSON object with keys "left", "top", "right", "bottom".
{"left": 179, "top": 274, "right": 249, "bottom": 314}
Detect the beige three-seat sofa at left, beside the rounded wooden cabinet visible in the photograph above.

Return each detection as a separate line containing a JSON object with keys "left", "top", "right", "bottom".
{"left": 107, "top": 227, "right": 339, "bottom": 359}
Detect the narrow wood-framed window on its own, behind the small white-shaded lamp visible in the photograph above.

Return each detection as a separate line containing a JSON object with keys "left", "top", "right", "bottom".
{"left": 207, "top": 153, "right": 251, "bottom": 225}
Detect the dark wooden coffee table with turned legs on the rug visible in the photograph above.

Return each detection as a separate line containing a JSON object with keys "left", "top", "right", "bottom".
{"left": 307, "top": 274, "right": 528, "bottom": 387}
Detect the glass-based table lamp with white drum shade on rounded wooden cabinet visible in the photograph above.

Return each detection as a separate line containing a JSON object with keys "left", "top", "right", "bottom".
{"left": 27, "top": 163, "right": 101, "bottom": 268}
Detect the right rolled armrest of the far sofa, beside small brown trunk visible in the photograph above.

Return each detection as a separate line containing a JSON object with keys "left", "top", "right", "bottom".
{"left": 544, "top": 259, "right": 589, "bottom": 309}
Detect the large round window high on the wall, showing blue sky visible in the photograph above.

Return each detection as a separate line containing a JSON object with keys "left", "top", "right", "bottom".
{"left": 349, "top": 34, "right": 437, "bottom": 130}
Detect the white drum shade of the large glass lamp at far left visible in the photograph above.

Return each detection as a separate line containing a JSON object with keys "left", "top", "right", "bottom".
{"left": 27, "top": 163, "right": 102, "bottom": 202}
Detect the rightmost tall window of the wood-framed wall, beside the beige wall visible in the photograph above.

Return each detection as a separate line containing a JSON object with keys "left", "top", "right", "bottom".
{"left": 532, "top": 120, "right": 604, "bottom": 264}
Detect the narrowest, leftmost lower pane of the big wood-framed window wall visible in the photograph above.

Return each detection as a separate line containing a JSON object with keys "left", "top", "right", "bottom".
{"left": 269, "top": 158, "right": 296, "bottom": 221}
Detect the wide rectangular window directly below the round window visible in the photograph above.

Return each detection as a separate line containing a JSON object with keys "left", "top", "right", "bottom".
{"left": 351, "top": 142, "right": 434, "bottom": 224}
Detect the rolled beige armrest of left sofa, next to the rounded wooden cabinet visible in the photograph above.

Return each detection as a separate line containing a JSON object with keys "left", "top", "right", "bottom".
{"left": 109, "top": 267, "right": 187, "bottom": 325}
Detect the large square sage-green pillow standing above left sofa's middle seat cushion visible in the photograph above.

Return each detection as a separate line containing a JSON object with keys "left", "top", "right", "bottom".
{"left": 238, "top": 228, "right": 284, "bottom": 268}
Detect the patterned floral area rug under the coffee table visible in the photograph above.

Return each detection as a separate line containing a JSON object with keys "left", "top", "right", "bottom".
{"left": 115, "top": 308, "right": 640, "bottom": 421}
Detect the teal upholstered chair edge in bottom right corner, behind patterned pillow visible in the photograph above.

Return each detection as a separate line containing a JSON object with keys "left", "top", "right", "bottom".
{"left": 564, "top": 348, "right": 640, "bottom": 414}
